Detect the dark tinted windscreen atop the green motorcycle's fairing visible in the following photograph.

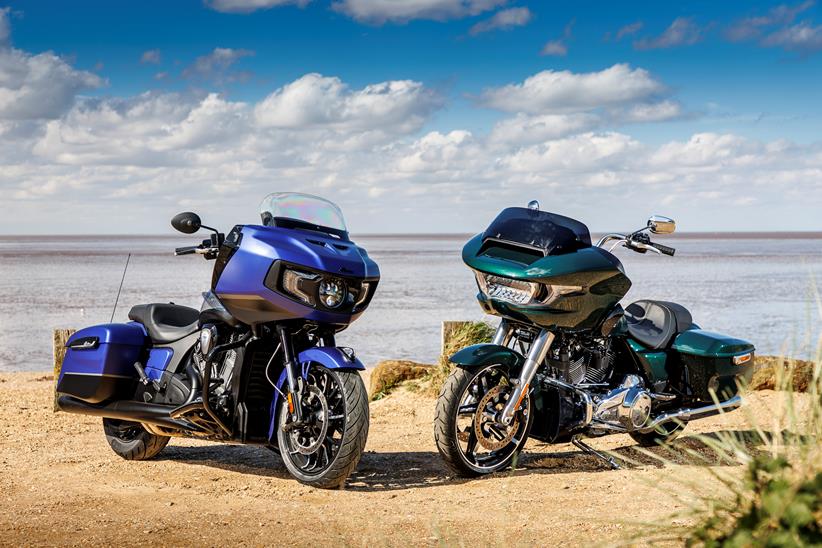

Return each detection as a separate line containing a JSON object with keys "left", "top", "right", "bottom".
{"left": 482, "top": 207, "right": 591, "bottom": 255}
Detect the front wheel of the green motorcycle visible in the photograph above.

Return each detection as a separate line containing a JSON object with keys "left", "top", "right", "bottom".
{"left": 434, "top": 365, "right": 533, "bottom": 477}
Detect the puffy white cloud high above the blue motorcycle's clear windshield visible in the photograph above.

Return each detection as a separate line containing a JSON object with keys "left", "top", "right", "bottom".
{"left": 254, "top": 74, "right": 442, "bottom": 133}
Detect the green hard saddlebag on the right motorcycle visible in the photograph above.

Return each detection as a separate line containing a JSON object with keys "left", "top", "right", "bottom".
{"left": 672, "top": 329, "right": 754, "bottom": 403}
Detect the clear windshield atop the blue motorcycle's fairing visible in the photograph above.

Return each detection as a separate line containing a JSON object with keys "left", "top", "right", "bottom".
{"left": 260, "top": 192, "right": 348, "bottom": 233}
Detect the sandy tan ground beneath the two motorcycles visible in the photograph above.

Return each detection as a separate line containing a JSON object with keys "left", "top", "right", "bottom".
{"left": 0, "top": 373, "right": 800, "bottom": 546}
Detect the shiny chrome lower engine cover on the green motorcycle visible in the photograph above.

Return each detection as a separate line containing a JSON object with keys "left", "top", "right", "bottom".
{"left": 592, "top": 375, "right": 651, "bottom": 432}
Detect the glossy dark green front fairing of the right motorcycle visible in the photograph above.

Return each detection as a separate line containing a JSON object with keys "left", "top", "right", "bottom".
{"left": 462, "top": 234, "right": 631, "bottom": 330}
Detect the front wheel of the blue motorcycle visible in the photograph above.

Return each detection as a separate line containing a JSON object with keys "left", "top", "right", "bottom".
{"left": 277, "top": 364, "right": 368, "bottom": 489}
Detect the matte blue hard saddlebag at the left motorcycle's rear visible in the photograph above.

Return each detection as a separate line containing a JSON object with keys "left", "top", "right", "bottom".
{"left": 57, "top": 322, "right": 146, "bottom": 403}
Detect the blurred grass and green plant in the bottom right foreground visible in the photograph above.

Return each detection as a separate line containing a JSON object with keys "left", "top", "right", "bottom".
{"left": 645, "top": 345, "right": 822, "bottom": 547}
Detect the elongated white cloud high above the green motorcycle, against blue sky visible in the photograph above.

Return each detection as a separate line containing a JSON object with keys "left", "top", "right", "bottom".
{"left": 480, "top": 64, "right": 666, "bottom": 114}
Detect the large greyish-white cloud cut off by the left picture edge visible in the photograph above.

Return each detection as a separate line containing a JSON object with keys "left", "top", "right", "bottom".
{"left": 0, "top": 48, "right": 105, "bottom": 120}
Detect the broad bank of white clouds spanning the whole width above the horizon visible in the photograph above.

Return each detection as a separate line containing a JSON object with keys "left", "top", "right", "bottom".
{"left": 0, "top": 31, "right": 822, "bottom": 233}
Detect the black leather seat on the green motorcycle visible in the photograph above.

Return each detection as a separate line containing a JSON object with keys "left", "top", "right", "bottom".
{"left": 625, "top": 300, "right": 693, "bottom": 349}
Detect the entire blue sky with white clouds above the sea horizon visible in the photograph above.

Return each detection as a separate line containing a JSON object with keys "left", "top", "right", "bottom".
{"left": 0, "top": 0, "right": 822, "bottom": 234}
